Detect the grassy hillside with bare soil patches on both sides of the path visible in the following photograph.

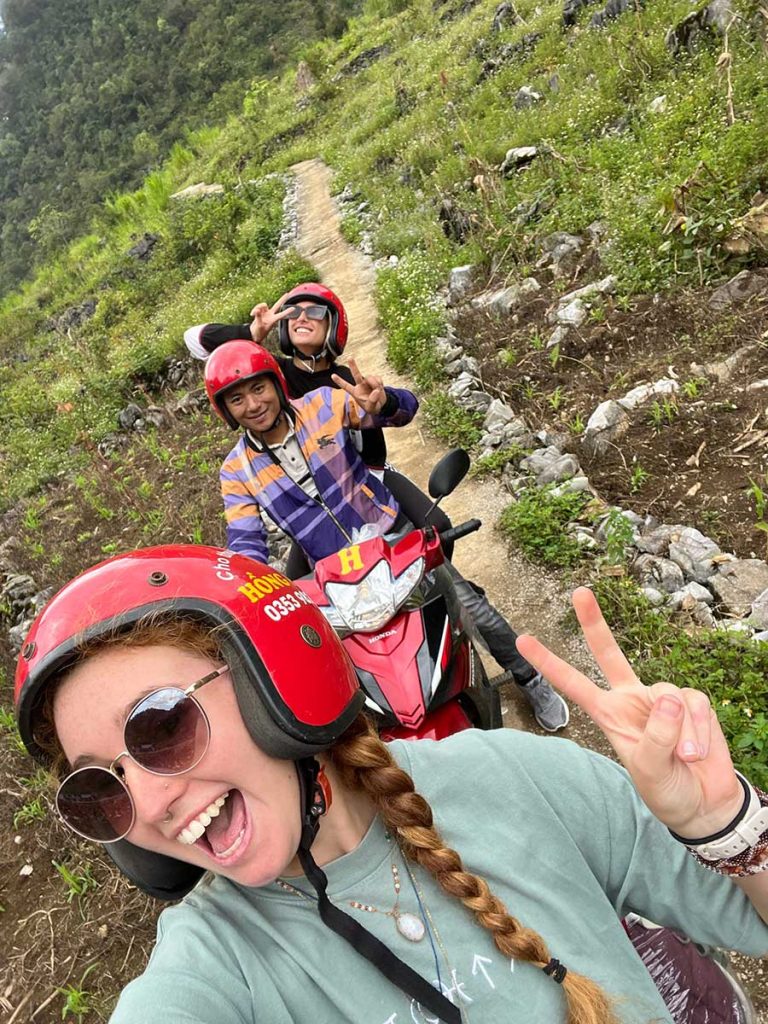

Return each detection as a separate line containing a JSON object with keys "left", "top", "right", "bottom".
{"left": 0, "top": 0, "right": 768, "bottom": 1024}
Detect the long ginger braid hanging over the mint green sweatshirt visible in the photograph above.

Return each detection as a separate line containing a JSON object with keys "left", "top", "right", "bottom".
{"left": 328, "top": 715, "right": 620, "bottom": 1024}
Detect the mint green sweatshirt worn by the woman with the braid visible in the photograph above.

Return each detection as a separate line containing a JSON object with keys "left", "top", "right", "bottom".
{"left": 111, "top": 729, "right": 768, "bottom": 1024}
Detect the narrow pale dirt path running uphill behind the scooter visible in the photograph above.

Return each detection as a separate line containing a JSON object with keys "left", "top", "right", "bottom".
{"left": 293, "top": 160, "right": 603, "bottom": 749}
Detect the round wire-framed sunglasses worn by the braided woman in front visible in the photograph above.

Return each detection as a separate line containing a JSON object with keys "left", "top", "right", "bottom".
{"left": 56, "top": 665, "right": 228, "bottom": 843}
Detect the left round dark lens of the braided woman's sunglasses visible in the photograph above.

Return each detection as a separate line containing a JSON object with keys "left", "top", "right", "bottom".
{"left": 56, "top": 768, "right": 133, "bottom": 843}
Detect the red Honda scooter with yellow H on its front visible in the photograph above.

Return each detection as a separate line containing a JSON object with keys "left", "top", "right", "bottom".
{"left": 297, "top": 449, "right": 506, "bottom": 739}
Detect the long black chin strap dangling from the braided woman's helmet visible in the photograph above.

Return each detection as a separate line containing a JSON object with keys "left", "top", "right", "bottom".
{"left": 296, "top": 758, "right": 461, "bottom": 1024}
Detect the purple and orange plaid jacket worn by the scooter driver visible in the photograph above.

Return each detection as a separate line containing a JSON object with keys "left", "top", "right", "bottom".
{"left": 220, "top": 387, "right": 419, "bottom": 563}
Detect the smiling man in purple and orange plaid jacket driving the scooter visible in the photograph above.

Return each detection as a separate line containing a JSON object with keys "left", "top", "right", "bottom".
{"left": 205, "top": 341, "right": 569, "bottom": 732}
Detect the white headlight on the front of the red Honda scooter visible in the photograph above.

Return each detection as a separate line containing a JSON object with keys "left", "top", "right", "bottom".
{"left": 326, "top": 558, "right": 424, "bottom": 633}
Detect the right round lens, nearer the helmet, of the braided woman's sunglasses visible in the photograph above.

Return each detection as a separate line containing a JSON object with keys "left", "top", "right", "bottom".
{"left": 125, "top": 686, "right": 210, "bottom": 775}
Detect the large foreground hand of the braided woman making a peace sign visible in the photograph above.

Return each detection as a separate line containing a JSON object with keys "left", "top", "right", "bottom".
{"left": 517, "top": 587, "right": 743, "bottom": 839}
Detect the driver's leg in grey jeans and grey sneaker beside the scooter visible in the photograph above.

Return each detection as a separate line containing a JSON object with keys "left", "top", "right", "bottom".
{"left": 449, "top": 563, "right": 569, "bottom": 732}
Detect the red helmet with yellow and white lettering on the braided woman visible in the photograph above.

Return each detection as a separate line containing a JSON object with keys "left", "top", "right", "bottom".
{"left": 14, "top": 545, "right": 365, "bottom": 899}
